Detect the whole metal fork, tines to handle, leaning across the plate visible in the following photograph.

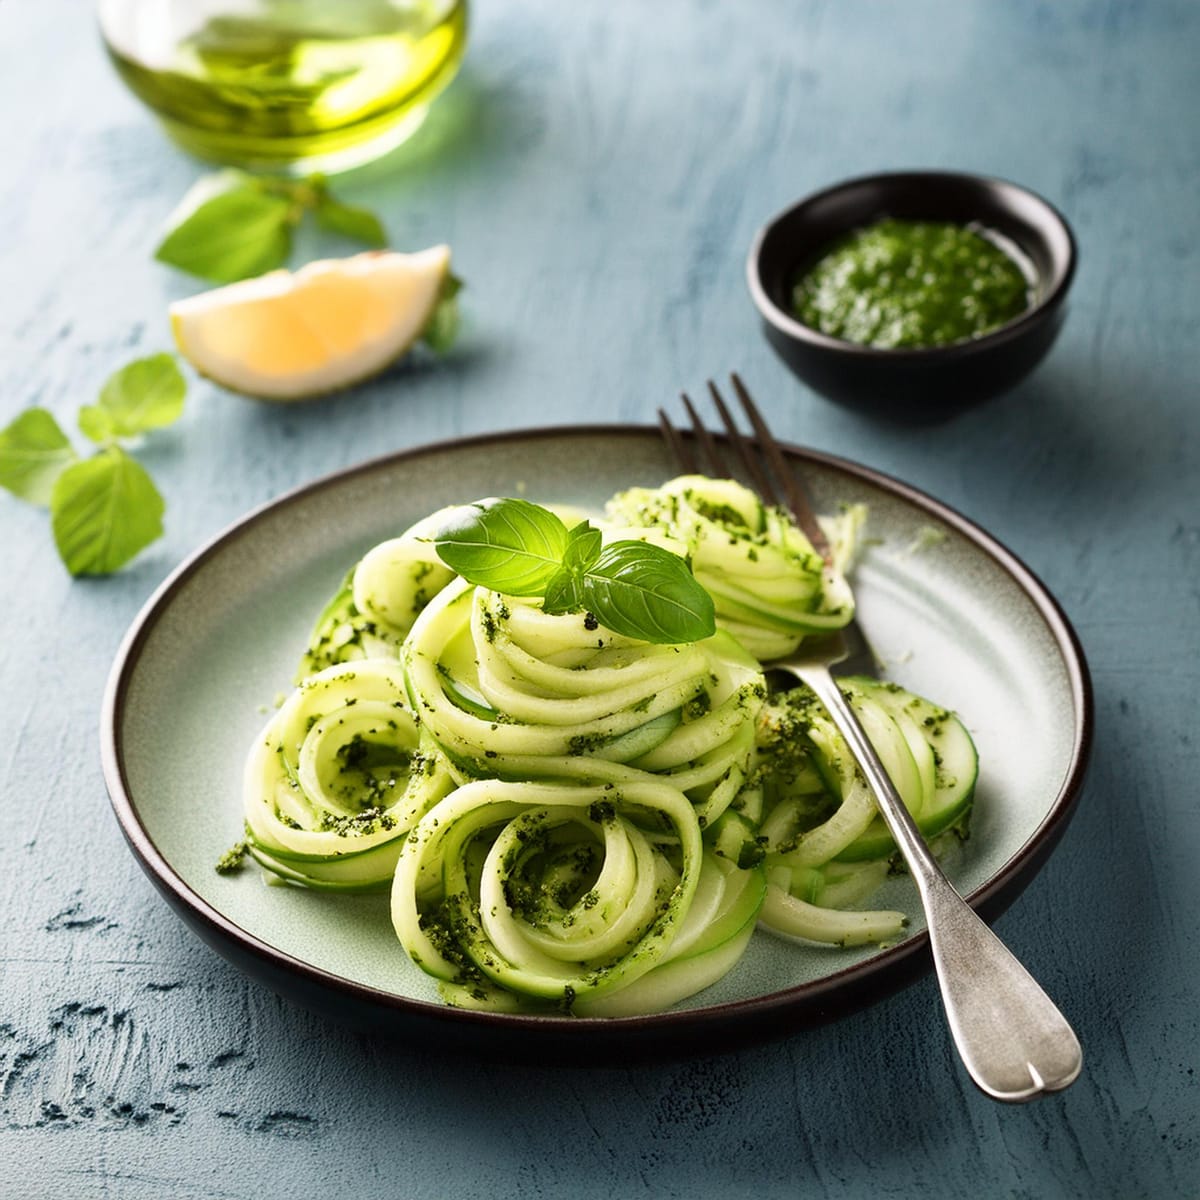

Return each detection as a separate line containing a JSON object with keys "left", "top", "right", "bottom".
{"left": 659, "top": 374, "right": 1082, "bottom": 1103}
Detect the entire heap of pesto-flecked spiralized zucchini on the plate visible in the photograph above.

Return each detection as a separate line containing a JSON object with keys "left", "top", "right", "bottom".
{"left": 246, "top": 476, "right": 976, "bottom": 1016}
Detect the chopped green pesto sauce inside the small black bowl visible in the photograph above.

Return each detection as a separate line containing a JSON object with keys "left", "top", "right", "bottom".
{"left": 792, "top": 217, "right": 1032, "bottom": 349}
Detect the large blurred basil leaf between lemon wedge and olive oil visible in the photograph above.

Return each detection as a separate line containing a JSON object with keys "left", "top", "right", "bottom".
{"left": 155, "top": 176, "right": 295, "bottom": 283}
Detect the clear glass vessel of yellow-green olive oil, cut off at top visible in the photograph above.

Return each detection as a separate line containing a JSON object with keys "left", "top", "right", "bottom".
{"left": 100, "top": 0, "right": 467, "bottom": 173}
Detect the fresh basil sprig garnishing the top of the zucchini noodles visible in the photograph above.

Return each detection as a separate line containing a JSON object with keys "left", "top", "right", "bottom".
{"left": 433, "top": 498, "right": 716, "bottom": 644}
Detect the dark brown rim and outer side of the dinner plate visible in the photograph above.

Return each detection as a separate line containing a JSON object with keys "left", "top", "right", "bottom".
{"left": 100, "top": 422, "right": 1094, "bottom": 1061}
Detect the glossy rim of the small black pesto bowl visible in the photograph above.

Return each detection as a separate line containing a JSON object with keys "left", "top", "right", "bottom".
{"left": 746, "top": 169, "right": 1079, "bottom": 365}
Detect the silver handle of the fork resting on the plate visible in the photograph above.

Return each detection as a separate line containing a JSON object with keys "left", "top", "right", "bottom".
{"left": 776, "top": 664, "right": 1084, "bottom": 1102}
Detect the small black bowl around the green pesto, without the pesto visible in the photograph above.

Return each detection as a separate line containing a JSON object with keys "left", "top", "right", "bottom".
{"left": 746, "top": 172, "right": 1075, "bottom": 421}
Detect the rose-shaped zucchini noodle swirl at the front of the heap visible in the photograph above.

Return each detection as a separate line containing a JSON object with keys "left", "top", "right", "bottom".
{"left": 392, "top": 776, "right": 762, "bottom": 1015}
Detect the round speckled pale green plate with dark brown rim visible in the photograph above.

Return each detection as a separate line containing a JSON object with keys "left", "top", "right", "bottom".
{"left": 101, "top": 427, "right": 1092, "bottom": 1062}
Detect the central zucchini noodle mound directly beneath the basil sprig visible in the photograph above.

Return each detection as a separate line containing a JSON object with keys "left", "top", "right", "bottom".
{"left": 401, "top": 581, "right": 766, "bottom": 824}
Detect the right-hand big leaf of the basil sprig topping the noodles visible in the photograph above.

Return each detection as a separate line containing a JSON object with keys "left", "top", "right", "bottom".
{"left": 582, "top": 541, "right": 716, "bottom": 644}
